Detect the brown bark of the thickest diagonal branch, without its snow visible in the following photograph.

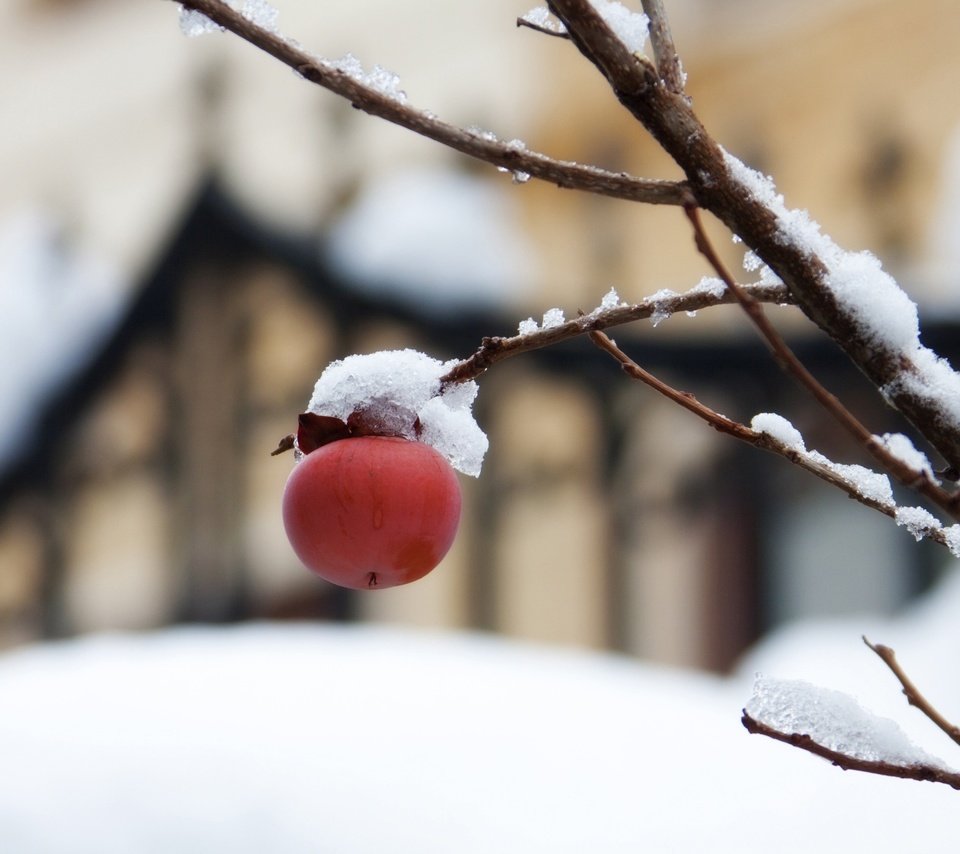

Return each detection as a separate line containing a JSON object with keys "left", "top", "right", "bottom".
{"left": 548, "top": 0, "right": 960, "bottom": 470}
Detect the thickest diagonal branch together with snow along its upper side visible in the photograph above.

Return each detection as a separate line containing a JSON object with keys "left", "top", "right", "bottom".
{"left": 548, "top": 0, "right": 960, "bottom": 471}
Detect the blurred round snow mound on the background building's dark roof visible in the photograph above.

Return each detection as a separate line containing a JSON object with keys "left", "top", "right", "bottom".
{"left": 325, "top": 168, "right": 537, "bottom": 314}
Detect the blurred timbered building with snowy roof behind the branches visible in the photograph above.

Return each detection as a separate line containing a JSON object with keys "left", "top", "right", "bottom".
{"left": 0, "top": 0, "right": 960, "bottom": 669}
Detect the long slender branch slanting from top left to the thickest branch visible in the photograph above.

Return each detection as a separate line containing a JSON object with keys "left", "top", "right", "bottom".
{"left": 172, "top": 0, "right": 689, "bottom": 205}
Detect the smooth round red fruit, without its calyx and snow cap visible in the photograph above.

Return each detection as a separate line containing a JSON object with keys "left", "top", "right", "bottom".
{"left": 283, "top": 436, "right": 461, "bottom": 589}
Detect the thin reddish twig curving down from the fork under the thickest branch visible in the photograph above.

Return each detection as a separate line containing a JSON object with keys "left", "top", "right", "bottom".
{"left": 683, "top": 205, "right": 960, "bottom": 519}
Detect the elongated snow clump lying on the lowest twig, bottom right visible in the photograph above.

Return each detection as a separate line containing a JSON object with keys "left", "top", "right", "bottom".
{"left": 746, "top": 674, "right": 947, "bottom": 770}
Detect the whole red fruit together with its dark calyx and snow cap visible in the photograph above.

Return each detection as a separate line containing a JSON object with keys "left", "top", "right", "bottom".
{"left": 274, "top": 350, "right": 487, "bottom": 589}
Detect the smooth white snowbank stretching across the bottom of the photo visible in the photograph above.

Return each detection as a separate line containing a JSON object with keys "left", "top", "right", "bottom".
{"left": 0, "top": 576, "right": 960, "bottom": 854}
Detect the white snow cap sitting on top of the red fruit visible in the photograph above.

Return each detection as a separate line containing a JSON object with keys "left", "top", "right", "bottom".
{"left": 307, "top": 350, "right": 489, "bottom": 477}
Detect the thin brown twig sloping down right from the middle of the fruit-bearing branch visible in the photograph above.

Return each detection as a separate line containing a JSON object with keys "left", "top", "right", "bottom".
{"left": 588, "top": 331, "right": 950, "bottom": 548}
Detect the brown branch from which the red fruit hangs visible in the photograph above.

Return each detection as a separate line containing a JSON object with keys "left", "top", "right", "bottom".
{"left": 443, "top": 285, "right": 790, "bottom": 384}
